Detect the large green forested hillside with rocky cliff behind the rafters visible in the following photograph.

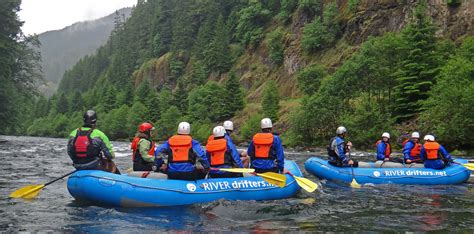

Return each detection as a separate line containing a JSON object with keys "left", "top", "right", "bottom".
{"left": 16, "top": 0, "right": 474, "bottom": 149}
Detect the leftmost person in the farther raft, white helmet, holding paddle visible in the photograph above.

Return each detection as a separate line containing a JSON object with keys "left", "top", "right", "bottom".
{"left": 327, "top": 126, "right": 359, "bottom": 167}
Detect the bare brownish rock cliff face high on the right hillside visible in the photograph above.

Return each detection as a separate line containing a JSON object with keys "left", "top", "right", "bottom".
{"left": 234, "top": 0, "right": 474, "bottom": 100}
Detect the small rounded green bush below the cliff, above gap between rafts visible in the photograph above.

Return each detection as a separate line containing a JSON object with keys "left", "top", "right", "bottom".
{"left": 296, "top": 64, "right": 327, "bottom": 95}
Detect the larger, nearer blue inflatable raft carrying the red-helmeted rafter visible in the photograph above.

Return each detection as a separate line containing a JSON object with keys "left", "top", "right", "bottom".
{"left": 67, "top": 160, "right": 302, "bottom": 207}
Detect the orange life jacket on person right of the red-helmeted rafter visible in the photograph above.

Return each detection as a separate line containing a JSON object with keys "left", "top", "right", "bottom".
{"left": 168, "top": 135, "right": 193, "bottom": 163}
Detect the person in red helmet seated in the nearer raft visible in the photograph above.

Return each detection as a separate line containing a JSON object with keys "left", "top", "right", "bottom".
{"left": 130, "top": 123, "right": 155, "bottom": 171}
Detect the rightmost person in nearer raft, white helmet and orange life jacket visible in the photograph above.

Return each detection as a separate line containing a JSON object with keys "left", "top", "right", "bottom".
{"left": 247, "top": 118, "right": 287, "bottom": 173}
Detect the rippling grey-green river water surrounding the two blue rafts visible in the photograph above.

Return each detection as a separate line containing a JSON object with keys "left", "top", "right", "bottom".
{"left": 0, "top": 136, "right": 474, "bottom": 232}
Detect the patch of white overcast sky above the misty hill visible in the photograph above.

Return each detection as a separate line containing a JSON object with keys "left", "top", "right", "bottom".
{"left": 18, "top": 0, "right": 137, "bottom": 34}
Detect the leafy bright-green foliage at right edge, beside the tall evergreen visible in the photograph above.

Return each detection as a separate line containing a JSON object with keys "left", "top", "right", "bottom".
{"left": 420, "top": 37, "right": 474, "bottom": 149}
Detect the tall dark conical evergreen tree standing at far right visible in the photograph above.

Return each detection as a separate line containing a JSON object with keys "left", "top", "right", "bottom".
{"left": 395, "top": 1, "right": 439, "bottom": 122}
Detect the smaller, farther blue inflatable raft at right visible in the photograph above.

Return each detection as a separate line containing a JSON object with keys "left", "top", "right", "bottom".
{"left": 305, "top": 157, "right": 471, "bottom": 185}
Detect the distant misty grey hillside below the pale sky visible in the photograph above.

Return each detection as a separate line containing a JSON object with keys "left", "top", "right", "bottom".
{"left": 38, "top": 8, "right": 132, "bottom": 96}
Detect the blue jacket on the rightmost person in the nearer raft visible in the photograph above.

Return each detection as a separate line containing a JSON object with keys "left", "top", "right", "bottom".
{"left": 247, "top": 135, "right": 285, "bottom": 171}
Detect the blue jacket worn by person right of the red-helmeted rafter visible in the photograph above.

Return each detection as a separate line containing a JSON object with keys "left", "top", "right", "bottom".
{"left": 155, "top": 139, "right": 210, "bottom": 172}
